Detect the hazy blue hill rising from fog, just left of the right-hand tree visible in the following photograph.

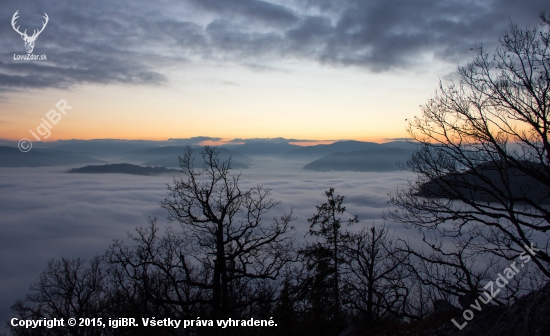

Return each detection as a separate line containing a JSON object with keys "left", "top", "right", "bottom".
{"left": 303, "top": 145, "right": 413, "bottom": 172}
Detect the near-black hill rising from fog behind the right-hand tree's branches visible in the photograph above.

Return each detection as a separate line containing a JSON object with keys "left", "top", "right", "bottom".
{"left": 417, "top": 162, "right": 550, "bottom": 204}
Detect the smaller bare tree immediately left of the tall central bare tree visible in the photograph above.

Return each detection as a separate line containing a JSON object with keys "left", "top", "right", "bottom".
{"left": 104, "top": 220, "right": 210, "bottom": 319}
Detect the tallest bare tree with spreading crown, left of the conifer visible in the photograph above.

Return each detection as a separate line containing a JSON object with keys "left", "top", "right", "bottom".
{"left": 161, "top": 146, "right": 295, "bottom": 318}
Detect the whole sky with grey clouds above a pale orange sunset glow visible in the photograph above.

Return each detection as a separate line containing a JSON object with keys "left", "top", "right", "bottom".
{"left": 0, "top": 0, "right": 550, "bottom": 142}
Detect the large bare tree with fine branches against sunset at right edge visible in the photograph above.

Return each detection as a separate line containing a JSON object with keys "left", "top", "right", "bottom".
{"left": 388, "top": 13, "right": 550, "bottom": 280}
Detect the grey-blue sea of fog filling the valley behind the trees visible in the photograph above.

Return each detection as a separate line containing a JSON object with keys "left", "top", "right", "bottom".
{"left": 0, "top": 158, "right": 414, "bottom": 329}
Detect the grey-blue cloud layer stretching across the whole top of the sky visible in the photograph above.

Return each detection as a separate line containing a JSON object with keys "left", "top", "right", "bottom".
{"left": 0, "top": 0, "right": 550, "bottom": 91}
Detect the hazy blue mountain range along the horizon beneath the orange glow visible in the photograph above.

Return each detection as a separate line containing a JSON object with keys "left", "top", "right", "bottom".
{"left": 0, "top": 138, "right": 415, "bottom": 169}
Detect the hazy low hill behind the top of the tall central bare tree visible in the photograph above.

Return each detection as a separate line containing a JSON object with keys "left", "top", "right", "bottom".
{"left": 142, "top": 146, "right": 252, "bottom": 169}
